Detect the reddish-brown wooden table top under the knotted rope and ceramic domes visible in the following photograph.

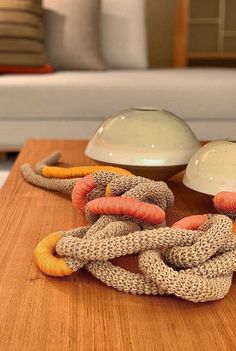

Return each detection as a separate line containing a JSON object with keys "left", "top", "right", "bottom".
{"left": 0, "top": 140, "right": 236, "bottom": 351}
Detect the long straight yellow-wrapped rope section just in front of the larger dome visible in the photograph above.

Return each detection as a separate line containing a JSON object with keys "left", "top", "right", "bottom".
{"left": 42, "top": 166, "right": 132, "bottom": 179}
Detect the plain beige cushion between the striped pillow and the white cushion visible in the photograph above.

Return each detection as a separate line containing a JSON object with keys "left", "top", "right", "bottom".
{"left": 44, "top": 0, "right": 105, "bottom": 70}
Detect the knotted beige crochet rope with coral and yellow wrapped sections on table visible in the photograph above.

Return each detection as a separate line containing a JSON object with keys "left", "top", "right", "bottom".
{"left": 22, "top": 155, "right": 236, "bottom": 302}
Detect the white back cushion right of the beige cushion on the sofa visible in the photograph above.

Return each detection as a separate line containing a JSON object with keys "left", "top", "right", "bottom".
{"left": 101, "top": 0, "right": 148, "bottom": 68}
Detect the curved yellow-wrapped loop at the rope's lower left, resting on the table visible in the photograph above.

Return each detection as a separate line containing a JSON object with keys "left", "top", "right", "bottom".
{"left": 34, "top": 232, "right": 73, "bottom": 277}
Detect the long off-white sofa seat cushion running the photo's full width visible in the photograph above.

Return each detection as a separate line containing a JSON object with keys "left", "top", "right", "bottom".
{"left": 0, "top": 68, "right": 236, "bottom": 120}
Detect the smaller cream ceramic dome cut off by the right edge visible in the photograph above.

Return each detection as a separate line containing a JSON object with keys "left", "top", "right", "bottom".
{"left": 183, "top": 140, "right": 236, "bottom": 195}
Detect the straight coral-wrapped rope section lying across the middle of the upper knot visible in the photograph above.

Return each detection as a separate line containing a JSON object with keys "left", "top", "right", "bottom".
{"left": 86, "top": 197, "right": 165, "bottom": 224}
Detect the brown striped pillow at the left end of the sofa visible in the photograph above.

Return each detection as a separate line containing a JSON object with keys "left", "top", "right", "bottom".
{"left": 0, "top": 0, "right": 46, "bottom": 67}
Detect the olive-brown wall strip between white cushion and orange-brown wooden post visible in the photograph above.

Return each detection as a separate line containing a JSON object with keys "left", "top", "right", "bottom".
{"left": 146, "top": 0, "right": 176, "bottom": 67}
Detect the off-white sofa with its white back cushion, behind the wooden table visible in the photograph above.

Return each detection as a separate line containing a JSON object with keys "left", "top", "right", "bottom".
{"left": 0, "top": 0, "right": 236, "bottom": 151}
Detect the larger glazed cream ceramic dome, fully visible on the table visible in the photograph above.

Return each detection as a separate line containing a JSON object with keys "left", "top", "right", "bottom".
{"left": 85, "top": 108, "right": 200, "bottom": 180}
